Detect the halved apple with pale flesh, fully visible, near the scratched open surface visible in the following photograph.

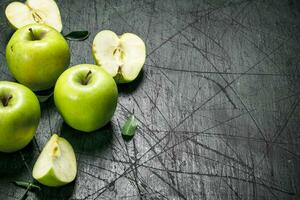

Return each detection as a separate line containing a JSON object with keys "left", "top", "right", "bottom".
{"left": 92, "top": 30, "right": 146, "bottom": 83}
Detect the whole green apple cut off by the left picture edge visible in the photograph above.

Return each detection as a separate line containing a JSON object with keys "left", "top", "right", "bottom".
{"left": 0, "top": 81, "right": 41, "bottom": 153}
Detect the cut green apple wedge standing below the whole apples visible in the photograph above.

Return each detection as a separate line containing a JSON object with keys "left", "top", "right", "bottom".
{"left": 32, "top": 134, "right": 77, "bottom": 187}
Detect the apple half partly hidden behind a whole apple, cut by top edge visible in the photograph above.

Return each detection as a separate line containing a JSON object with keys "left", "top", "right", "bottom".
{"left": 5, "top": 0, "right": 62, "bottom": 32}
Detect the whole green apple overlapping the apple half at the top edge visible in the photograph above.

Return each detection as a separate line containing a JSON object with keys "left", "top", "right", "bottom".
{"left": 6, "top": 24, "right": 70, "bottom": 91}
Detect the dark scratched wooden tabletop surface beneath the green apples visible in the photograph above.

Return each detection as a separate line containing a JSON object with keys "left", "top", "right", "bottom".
{"left": 0, "top": 0, "right": 300, "bottom": 200}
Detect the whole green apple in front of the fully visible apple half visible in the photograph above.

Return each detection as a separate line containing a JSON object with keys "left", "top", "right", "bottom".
{"left": 54, "top": 64, "right": 118, "bottom": 132}
